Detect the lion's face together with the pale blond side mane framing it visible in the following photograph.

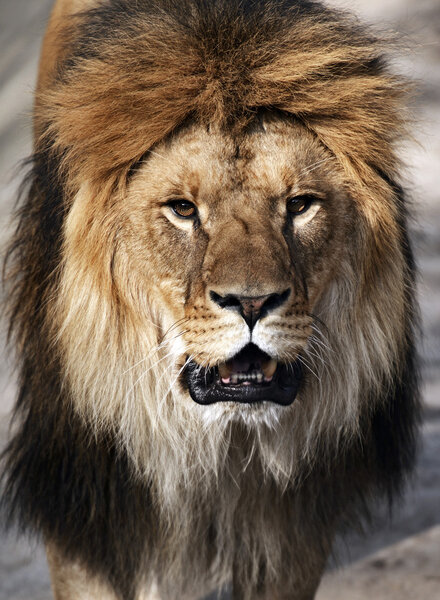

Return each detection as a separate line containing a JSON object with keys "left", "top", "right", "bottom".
{"left": 58, "top": 94, "right": 404, "bottom": 482}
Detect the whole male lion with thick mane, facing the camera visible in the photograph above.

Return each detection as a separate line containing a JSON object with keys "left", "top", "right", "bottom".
{"left": 3, "top": 0, "right": 420, "bottom": 600}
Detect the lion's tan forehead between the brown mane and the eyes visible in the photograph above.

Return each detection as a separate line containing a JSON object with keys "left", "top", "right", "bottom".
{"left": 133, "top": 117, "right": 342, "bottom": 208}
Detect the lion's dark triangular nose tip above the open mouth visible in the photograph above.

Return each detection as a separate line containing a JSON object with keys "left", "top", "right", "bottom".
{"left": 209, "top": 288, "right": 290, "bottom": 329}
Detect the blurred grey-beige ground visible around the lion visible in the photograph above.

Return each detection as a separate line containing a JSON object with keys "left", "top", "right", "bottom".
{"left": 0, "top": 0, "right": 440, "bottom": 600}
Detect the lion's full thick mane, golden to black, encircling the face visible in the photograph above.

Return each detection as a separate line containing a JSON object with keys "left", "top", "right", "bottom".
{"left": 4, "top": 0, "right": 419, "bottom": 600}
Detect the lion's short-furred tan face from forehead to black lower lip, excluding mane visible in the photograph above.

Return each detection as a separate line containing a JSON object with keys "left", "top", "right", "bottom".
{"left": 111, "top": 117, "right": 353, "bottom": 418}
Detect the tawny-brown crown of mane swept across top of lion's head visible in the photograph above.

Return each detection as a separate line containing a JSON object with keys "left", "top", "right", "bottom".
{"left": 38, "top": 0, "right": 404, "bottom": 186}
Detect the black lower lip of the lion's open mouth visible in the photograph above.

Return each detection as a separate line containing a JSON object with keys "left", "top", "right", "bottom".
{"left": 182, "top": 345, "right": 303, "bottom": 406}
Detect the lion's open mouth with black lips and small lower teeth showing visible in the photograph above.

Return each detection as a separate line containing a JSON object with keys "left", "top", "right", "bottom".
{"left": 183, "top": 344, "right": 302, "bottom": 406}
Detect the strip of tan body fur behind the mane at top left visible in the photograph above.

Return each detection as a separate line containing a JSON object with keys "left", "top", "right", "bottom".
{"left": 37, "top": 0, "right": 100, "bottom": 103}
